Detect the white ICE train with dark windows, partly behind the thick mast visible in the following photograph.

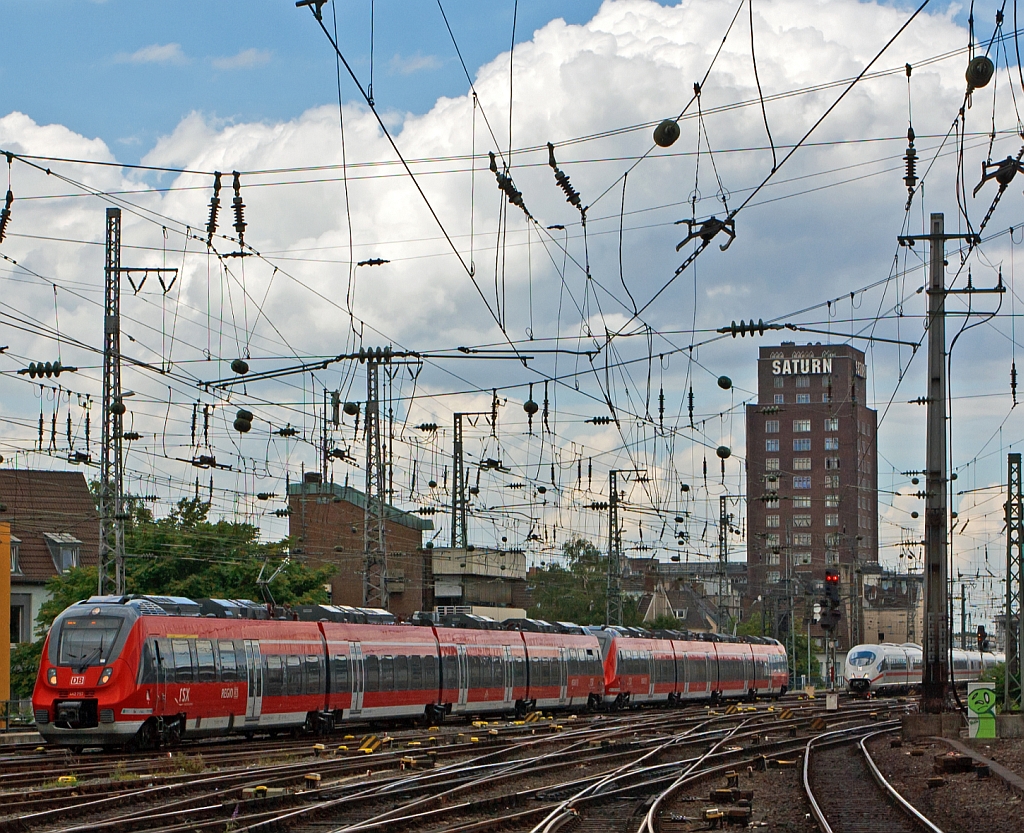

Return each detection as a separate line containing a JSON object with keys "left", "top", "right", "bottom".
{"left": 846, "top": 642, "right": 1006, "bottom": 696}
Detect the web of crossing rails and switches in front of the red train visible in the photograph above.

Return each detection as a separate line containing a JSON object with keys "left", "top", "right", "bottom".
{"left": 0, "top": 701, "right": 913, "bottom": 833}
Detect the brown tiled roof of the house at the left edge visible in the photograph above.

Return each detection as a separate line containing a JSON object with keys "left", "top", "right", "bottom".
{"left": 0, "top": 468, "right": 99, "bottom": 585}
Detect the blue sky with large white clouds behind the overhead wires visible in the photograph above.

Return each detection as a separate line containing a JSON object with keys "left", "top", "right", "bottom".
{"left": 0, "top": 0, "right": 1024, "bottom": 618}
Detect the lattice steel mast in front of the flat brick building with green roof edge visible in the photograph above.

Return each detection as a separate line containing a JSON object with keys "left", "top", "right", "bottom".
{"left": 362, "top": 355, "right": 390, "bottom": 610}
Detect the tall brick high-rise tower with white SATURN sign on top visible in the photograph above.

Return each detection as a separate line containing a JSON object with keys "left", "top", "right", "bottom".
{"left": 746, "top": 342, "right": 879, "bottom": 598}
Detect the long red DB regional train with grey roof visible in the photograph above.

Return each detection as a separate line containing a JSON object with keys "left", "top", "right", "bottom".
{"left": 33, "top": 596, "right": 787, "bottom": 748}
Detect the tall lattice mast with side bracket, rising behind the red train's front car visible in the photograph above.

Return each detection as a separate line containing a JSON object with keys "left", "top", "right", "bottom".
{"left": 96, "top": 208, "right": 178, "bottom": 595}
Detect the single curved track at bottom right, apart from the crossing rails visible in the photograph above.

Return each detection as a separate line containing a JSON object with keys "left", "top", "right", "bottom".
{"left": 804, "top": 730, "right": 942, "bottom": 833}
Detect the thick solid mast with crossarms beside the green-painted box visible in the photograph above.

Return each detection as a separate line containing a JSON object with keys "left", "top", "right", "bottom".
{"left": 899, "top": 214, "right": 987, "bottom": 714}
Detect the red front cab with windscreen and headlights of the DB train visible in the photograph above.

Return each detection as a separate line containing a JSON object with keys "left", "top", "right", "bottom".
{"left": 32, "top": 600, "right": 146, "bottom": 747}
